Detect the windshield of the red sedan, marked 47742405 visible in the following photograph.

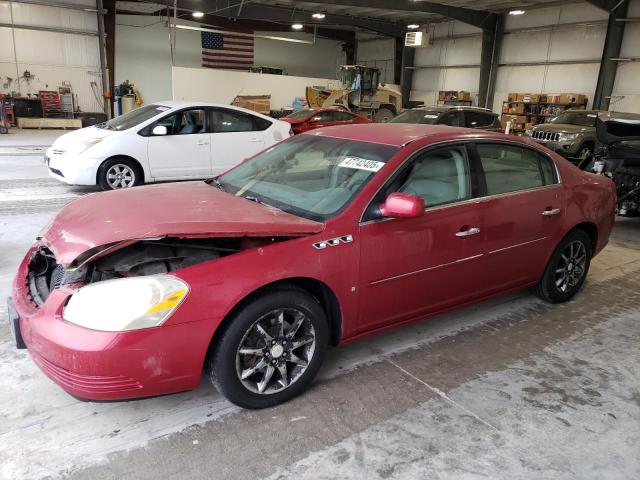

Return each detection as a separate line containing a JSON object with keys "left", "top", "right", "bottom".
{"left": 218, "top": 135, "right": 398, "bottom": 221}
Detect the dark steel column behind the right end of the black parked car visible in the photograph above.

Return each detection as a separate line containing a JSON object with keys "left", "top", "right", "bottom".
{"left": 478, "top": 15, "right": 504, "bottom": 109}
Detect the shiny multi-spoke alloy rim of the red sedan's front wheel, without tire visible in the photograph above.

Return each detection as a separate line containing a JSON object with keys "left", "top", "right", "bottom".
{"left": 236, "top": 308, "right": 316, "bottom": 394}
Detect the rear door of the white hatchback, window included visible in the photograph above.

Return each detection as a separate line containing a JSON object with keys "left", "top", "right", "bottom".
{"left": 209, "top": 108, "right": 269, "bottom": 175}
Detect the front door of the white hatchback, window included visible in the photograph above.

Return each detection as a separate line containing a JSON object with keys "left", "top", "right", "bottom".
{"left": 147, "top": 108, "right": 211, "bottom": 180}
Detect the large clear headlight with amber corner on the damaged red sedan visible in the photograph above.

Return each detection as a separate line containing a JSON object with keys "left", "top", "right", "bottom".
{"left": 62, "top": 275, "right": 189, "bottom": 332}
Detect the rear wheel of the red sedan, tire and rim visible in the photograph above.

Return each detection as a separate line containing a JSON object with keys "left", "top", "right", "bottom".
{"left": 536, "top": 229, "right": 592, "bottom": 303}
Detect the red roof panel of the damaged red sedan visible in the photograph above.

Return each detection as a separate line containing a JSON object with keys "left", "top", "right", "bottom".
{"left": 303, "top": 123, "right": 510, "bottom": 147}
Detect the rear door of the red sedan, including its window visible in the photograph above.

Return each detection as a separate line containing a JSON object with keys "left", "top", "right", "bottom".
{"left": 473, "top": 142, "right": 564, "bottom": 293}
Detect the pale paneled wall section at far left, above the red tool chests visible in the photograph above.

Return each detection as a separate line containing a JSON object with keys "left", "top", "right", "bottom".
{"left": 0, "top": 0, "right": 102, "bottom": 111}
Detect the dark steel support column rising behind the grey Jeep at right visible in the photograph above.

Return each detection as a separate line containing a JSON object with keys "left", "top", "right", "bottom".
{"left": 593, "top": 1, "right": 629, "bottom": 110}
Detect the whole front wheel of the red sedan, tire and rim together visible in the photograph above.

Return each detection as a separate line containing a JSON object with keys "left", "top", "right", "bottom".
{"left": 207, "top": 287, "right": 329, "bottom": 409}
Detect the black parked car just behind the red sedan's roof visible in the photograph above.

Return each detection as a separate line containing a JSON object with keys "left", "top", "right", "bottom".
{"left": 389, "top": 105, "right": 500, "bottom": 132}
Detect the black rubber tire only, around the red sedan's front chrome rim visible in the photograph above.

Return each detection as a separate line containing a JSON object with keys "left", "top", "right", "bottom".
{"left": 207, "top": 286, "right": 329, "bottom": 409}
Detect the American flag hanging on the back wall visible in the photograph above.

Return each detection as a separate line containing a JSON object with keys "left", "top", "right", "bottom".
{"left": 200, "top": 32, "right": 253, "bottom": 70}
